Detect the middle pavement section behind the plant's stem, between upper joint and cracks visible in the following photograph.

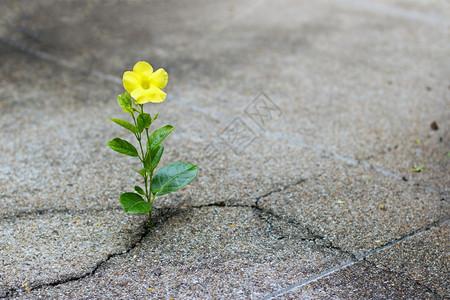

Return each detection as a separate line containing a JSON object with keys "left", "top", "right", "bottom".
{"left": 0, "top": 46, "right": 320, "bottom": 213}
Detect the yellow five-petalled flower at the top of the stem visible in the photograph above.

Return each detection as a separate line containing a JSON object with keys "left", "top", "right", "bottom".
{"left": 122, "top": 61, "right": 168, "bottom": 104}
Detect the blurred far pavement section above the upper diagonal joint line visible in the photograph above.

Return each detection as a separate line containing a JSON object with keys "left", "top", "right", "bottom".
{"left": 5, "top": 1, "right": 450, "bottom": 189}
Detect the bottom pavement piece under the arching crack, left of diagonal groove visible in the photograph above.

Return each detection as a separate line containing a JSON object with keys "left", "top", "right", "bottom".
{"left": 13, "top": 207, "right": 349, "bottom": 299}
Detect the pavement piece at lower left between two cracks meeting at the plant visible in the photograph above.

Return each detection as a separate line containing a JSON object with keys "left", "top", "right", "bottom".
{"left": 0, "top": 209, "right": 147, "bottom": 297}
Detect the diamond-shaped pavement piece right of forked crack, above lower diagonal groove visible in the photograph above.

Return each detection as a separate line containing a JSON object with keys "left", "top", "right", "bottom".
{"left": 259, "top": 165, "right": 449, "bottom": 256}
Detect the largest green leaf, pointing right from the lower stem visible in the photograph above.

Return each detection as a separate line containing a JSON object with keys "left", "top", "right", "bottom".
{"left": 151, "top": 162, "right": 198, "bottom": 196}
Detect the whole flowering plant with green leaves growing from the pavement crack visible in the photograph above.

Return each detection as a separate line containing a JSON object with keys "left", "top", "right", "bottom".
{"left": 107, "top": 61, "right": 198, "bottom": 227}
